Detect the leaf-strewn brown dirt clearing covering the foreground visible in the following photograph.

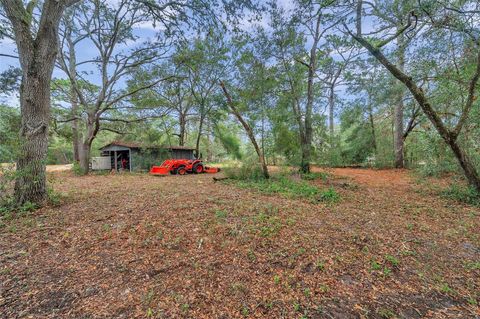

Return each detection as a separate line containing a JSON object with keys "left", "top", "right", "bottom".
{"left": 0, "top": 169, "right": 480, "bottom": 319}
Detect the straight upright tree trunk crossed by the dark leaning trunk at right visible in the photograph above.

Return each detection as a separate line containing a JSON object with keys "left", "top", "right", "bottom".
{"left": 393, "top": 33, "right": 405, "bottom": 168}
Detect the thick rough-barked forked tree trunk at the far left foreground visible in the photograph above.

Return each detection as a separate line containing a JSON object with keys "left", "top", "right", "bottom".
{"left": 0, "top": 0, "right": 74, "bottom": 205}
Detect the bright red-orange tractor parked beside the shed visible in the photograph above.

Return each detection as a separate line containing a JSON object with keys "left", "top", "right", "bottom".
{"left": 150, "top": 159, "right": 220, "bottom": 175}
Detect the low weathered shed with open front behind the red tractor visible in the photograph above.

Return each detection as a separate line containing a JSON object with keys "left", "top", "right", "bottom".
{"left": 98, "top": 141, "right": 195, "bottom": 171}
